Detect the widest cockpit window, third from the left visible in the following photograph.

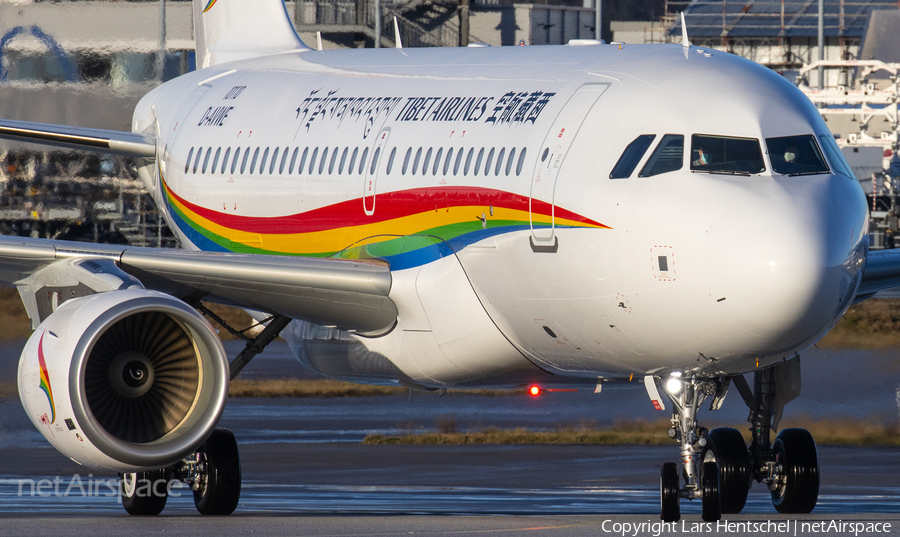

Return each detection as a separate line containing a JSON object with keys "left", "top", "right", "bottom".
{"left": 691, "top": 134, "right": 766, "bottom": 175}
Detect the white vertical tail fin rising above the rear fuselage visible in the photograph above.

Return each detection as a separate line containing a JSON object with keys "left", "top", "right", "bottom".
{"left": 193, "top": 0, "right": 310, "bottom": 69}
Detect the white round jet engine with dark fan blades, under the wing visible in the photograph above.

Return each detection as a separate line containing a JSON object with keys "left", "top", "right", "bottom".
{"left": 19, "top": 289, "right": 229, "bottom": 472}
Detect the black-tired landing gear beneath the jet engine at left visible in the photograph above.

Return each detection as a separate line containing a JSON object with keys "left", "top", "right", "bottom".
{"left": 119, "top": 428, "right": 241, "bottom": 515}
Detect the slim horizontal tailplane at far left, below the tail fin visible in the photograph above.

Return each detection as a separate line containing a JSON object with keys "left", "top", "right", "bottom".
{"left": 0, "top": 119, "right": 156, "bottom": 157}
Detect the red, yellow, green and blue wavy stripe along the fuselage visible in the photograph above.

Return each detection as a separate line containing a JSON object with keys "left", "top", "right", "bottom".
{"left": 163, "top": 182, "right": 609, "bottom": 270}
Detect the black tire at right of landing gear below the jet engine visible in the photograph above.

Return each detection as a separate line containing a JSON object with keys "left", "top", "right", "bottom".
{"left": 194, "top": 428, "right": 241, "bottom": 515}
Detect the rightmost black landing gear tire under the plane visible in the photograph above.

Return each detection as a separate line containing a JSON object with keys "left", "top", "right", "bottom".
{"left": 772, "top": 429, "right": 819, "bottom": 514}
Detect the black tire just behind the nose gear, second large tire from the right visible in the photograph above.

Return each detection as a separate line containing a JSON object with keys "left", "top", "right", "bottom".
{"left": 700, "top": 427, "right": 753, "bottom": 514}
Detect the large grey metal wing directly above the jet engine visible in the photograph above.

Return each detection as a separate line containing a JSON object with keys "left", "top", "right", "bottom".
{"left": 0, "top": 236, "right": 397, "bottom": 333}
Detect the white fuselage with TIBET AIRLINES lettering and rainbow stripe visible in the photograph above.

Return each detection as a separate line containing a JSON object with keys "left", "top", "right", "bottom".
{"left": 133, "top": 45, "right": 867, "bottom": 386}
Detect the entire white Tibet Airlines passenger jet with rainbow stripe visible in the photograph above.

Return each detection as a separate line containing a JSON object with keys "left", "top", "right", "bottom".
{"left": 0, "top": 0, "right": 900, "bottom": 520}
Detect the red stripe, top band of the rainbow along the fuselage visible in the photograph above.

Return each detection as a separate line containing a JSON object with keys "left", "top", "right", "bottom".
{"left": 167, "top": 187, "right": 606, "bottom": 234}
